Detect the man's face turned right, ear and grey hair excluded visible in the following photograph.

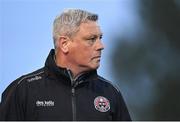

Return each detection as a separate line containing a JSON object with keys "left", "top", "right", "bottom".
{"left": 68, "top": 21, "right": 104, "bottom": 70}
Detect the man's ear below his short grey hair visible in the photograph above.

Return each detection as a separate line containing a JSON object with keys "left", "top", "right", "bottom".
{"left": 58, "top": 36, "right": 69, "bottom": 53}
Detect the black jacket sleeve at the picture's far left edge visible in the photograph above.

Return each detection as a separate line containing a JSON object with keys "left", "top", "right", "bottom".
{"left": 0, "top": 80, "right": 24, "bottom": 120}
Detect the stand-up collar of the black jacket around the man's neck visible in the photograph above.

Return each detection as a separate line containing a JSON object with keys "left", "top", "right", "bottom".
{"left": 45, "top": 49, "right": 97, "bottom": 86}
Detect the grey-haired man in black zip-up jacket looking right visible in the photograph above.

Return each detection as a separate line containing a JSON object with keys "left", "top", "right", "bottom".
{"left": 0, "top": 9, "right": 131, "bottom": 120}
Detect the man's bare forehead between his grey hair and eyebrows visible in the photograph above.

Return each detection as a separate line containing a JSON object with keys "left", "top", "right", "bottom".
{"left": 79, "top": 21, "right": 102, "bottom": 35}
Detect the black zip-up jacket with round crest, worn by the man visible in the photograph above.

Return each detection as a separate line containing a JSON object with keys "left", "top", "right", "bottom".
{"left": 0, "top": 50, "right": 131, "bottom": 121}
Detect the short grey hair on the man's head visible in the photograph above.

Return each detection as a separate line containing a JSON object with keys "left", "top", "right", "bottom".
{"left": 53, "top": 9, "right": 98, "bottom": 49}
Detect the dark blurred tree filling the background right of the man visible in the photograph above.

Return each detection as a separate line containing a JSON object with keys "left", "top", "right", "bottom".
{"left": 112, "top": 0, "right": 180, "bottom": 120}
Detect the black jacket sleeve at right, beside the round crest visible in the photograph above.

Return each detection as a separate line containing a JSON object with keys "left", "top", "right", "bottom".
{"left": 114, "top": 90, "right": 131, "bottom": 121}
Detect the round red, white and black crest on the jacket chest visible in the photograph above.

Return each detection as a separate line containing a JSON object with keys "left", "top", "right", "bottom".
{"left": 94, "top": 96, "right": 110, "bottom": 112}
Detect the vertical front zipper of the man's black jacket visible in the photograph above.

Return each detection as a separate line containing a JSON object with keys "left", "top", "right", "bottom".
{"left": 67, "top": 69, "right": 76, "bottom": 121}
